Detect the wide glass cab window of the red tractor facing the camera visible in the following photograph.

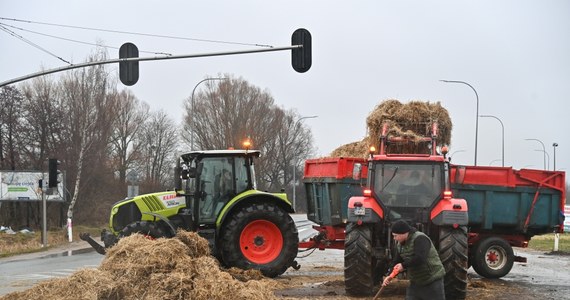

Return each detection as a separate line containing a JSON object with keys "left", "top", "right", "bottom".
{"left": 372, "top": 162, "right": 444, "bottom": 207}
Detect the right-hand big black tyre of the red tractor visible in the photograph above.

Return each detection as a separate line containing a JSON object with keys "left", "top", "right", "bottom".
{"left": 439, "top": 227, "right": 468, "bottom": 299}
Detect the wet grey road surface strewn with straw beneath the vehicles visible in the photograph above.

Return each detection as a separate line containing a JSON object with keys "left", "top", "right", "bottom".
{"left": 0, "top": 215, "right": 570, "bottom": 300}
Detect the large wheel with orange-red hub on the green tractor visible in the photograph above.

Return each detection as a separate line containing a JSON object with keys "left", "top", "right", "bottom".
{"left": 220, "top": 203, "right": 299, "bottom": 277}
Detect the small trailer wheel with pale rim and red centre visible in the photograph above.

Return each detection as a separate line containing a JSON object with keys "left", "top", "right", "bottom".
{"left": 473, "top": 237, "right": 515, "bottom": 278}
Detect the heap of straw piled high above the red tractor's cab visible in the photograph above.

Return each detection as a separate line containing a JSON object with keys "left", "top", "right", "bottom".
{"left": 331, "top": 99, "right": 452, "bottom": 157}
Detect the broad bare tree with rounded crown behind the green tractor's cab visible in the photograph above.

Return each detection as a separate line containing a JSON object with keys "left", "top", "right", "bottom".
{"left": 184, "top": 74, "right": 313, "bottom": 190}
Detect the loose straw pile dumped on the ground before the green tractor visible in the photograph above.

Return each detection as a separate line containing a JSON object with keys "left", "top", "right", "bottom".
{"left": 0, "top": 231, "right": 276, "bottom": 300}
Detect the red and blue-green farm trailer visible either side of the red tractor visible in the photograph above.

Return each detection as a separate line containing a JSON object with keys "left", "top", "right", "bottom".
{"left": 300, "top": 157, "right": 566, "bottom": 278}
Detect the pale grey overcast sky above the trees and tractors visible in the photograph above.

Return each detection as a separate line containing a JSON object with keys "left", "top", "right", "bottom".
{"left": 0, "top": 0, "right": 570, "bottom": 171}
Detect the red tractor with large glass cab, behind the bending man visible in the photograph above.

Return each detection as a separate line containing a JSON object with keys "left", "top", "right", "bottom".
{"left": 344, "top": 124, "right": 468, "bottom": 299}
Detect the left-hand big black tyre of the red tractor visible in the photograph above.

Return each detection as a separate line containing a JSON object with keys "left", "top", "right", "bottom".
{"left": 344, "top": 223, "right": 377, "bottom": 296}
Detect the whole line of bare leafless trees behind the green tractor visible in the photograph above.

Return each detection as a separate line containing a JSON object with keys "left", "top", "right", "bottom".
{"left": 0, "top": 49, "right": 314, "bottom": 228}
